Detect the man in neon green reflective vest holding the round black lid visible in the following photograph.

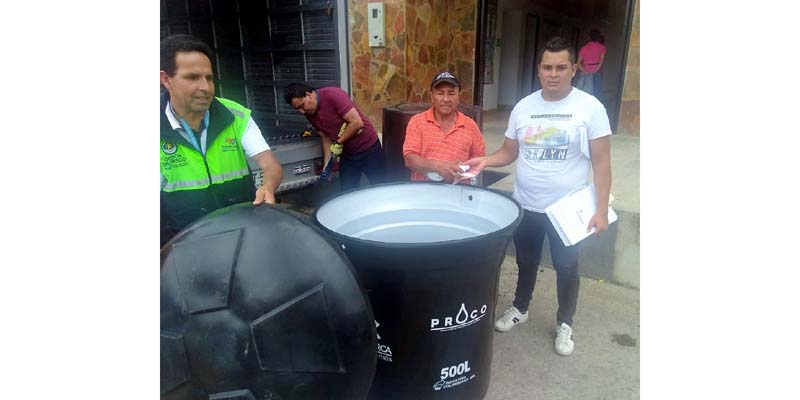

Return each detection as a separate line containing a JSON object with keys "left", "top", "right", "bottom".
{"left": 159, "top": 35, "right": 283, "bottom": 246}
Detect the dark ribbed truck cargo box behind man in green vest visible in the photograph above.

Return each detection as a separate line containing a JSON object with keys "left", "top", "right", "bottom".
{"left": 161, "top": 0, "right": 341, "bottom": 144}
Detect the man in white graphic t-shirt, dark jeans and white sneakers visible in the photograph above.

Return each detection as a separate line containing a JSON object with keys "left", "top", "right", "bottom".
{"left": 465, "top": 37, "right": 611, "bottom": 356}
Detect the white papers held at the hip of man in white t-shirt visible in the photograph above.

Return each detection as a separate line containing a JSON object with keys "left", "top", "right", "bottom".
{"left": 545, "top": 185, "right": 617, "bottom": 246}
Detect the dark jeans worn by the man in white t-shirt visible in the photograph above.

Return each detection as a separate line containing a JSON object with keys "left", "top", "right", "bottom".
{"left": 514, "top": 210, "right": 580, "bottom": 326}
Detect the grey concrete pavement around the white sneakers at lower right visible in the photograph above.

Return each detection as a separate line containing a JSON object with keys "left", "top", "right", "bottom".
{"left": 484, "top": 255, "right": 639, "bottom": 400}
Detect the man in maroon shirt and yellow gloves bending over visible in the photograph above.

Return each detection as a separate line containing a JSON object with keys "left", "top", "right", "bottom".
{"left": 284, "top": 83, "right": 386, "bottom": 190}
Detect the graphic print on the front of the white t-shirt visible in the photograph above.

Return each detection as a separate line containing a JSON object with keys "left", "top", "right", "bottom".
{"left": 522, "top": 114, "right": 572, "bottom": 162}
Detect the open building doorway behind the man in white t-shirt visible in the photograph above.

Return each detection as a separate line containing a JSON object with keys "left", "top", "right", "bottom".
{"left": 474, "top": 0, "right": 636, "bottom": 132}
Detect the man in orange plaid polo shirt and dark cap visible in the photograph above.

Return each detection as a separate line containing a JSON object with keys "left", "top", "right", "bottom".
{"left": 403, "top": 71, "right": 486, "bottom": 185}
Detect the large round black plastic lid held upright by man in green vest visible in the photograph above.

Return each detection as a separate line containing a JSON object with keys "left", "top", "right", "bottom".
{"left": 161, "top": 203, "right": 377, "bottom": 400}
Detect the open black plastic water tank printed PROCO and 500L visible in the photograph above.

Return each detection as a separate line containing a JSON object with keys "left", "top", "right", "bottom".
{"left": 313, "top": 183, "right": 522, "bottom": 400}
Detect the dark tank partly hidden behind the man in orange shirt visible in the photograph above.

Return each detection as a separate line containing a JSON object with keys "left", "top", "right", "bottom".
{"left": 382, "top": 103, "right": 483, "bottom": 186}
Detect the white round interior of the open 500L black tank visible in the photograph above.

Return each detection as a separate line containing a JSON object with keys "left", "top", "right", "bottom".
{"left": 317, "top": 183, "right": 520, "bottom": 243}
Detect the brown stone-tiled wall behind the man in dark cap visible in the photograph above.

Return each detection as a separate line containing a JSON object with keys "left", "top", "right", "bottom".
{"left": 349, "top": 0, "right": 477, "bottom": 130}
